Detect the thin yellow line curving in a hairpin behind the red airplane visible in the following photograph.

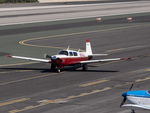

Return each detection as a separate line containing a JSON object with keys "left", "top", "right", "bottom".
{"left": 19, "top": 25, "right": 141, "bottom": 49}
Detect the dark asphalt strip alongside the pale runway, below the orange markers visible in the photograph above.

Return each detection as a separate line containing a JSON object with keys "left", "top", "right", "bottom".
{"left": 0, "top": 15, "right": 150, "bottom": 36}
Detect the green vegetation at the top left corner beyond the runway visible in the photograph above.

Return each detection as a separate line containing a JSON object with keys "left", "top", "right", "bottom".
{"left": 0, "top": 0, "right": 38, "bottom": 3}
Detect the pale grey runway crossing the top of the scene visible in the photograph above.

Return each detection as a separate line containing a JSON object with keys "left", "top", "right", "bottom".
{"left": 0, "top": 1, "right": 150, "bottom": 26}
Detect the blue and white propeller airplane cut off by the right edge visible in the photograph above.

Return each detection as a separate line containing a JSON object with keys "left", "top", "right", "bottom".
{"left": 120, "top": 84, "right": 150, "bottom": 113}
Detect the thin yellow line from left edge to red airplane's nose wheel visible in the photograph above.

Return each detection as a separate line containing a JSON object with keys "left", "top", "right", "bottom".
{"left": 0, "top": 72, "right": 63, "bottom": 86}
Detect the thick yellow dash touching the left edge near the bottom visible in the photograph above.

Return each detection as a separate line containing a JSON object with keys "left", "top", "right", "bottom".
{"left": 0, "top": 98, "right": 30, "bottom": 107}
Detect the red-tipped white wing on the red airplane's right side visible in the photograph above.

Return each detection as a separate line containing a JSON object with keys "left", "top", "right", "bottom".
{"left": 80, "top": 58, "right": 131, "bottom": 64}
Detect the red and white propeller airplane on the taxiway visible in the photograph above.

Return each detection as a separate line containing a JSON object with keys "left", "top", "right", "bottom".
{"left": 8, "top": 40, "right": 130, "bottom": 72}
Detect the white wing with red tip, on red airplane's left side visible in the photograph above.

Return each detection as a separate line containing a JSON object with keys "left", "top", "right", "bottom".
{"left": 8, "top": 55, "right": 51, "bottom": 63}
